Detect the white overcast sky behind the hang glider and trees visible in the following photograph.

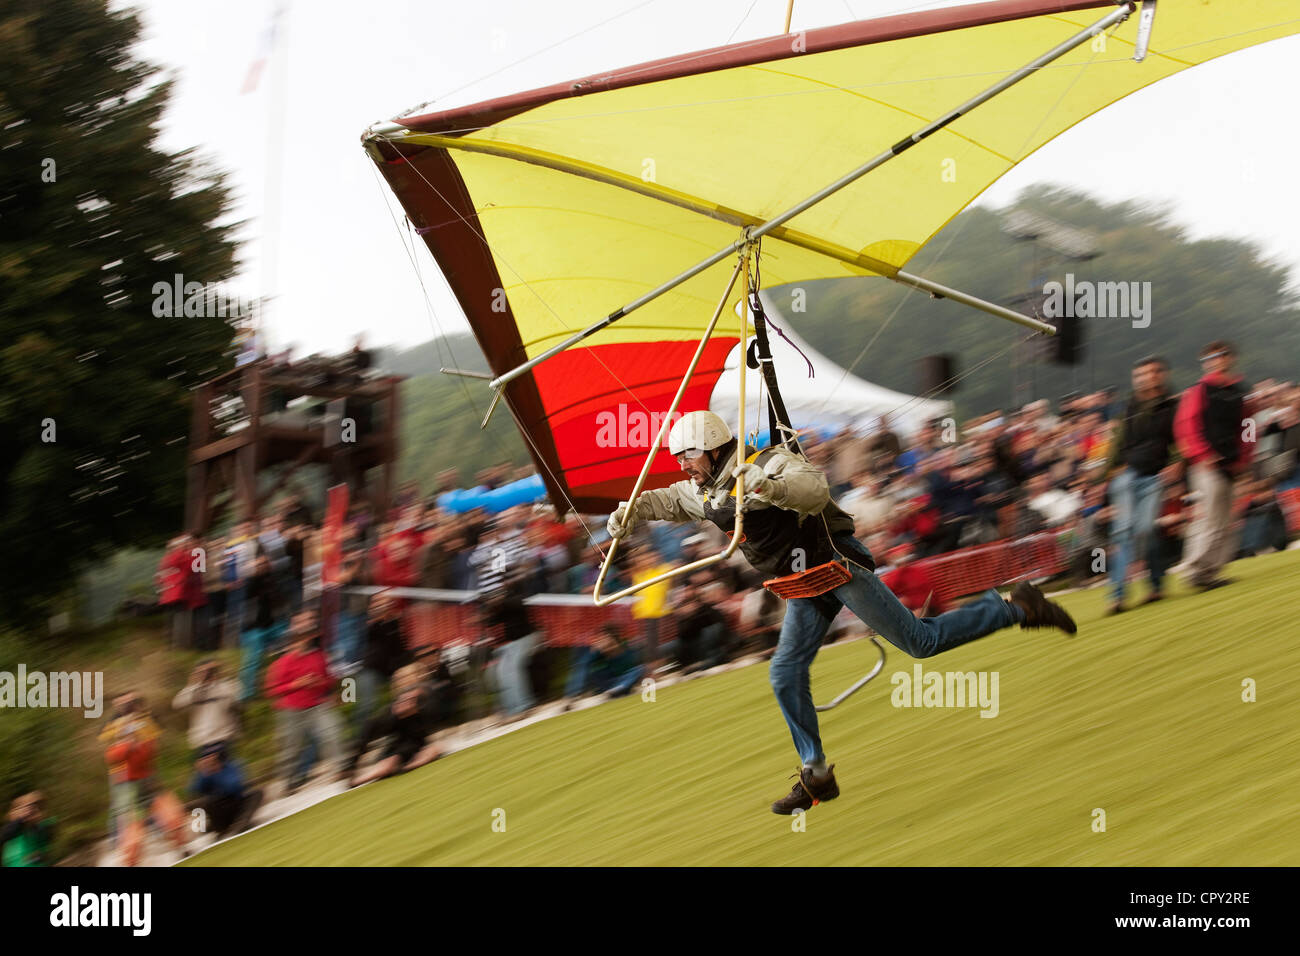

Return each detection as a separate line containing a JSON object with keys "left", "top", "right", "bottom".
{"left": 122, "top": 0, "right": 1300, "bottom": 355}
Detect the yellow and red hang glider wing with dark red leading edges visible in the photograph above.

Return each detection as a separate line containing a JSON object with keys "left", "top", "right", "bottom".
{"left": 363, "top": 0, "right": 1300, "bottom": 512}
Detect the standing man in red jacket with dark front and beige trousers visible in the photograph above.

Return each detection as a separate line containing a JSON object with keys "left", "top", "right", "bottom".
{"left": 1174, "top": 342, "right": 1251, "bottom": 591}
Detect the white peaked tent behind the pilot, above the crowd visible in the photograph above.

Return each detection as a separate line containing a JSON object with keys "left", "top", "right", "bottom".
{"left": 709, "top": 291, "right": 953, "bottom": 436}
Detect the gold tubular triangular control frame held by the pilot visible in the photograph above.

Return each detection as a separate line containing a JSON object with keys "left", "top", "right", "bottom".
{"left": 592, "top": 243, "right": 753, "bottom": 607}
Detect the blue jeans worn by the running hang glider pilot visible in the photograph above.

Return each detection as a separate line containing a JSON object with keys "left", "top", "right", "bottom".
{"left": 770, "top": 548, "right": 1024, "bottom": 765}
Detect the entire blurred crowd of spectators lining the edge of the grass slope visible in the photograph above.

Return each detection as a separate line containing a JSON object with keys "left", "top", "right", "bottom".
{"left": 50, "top": 343, "right": 1300, "bottom": 857}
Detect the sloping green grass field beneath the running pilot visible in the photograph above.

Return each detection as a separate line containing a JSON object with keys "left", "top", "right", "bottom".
{"left": 190, "top": 551, "right": 1300, "bottom": 866}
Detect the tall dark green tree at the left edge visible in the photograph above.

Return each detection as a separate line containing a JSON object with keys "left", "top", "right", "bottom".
{"left": 0, "top": 0, "right": 239, "bottom": 620}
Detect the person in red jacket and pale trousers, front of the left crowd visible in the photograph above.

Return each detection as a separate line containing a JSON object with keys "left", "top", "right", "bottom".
{"left": 267, "top": 607, "right": 343, "bottom": 792}
